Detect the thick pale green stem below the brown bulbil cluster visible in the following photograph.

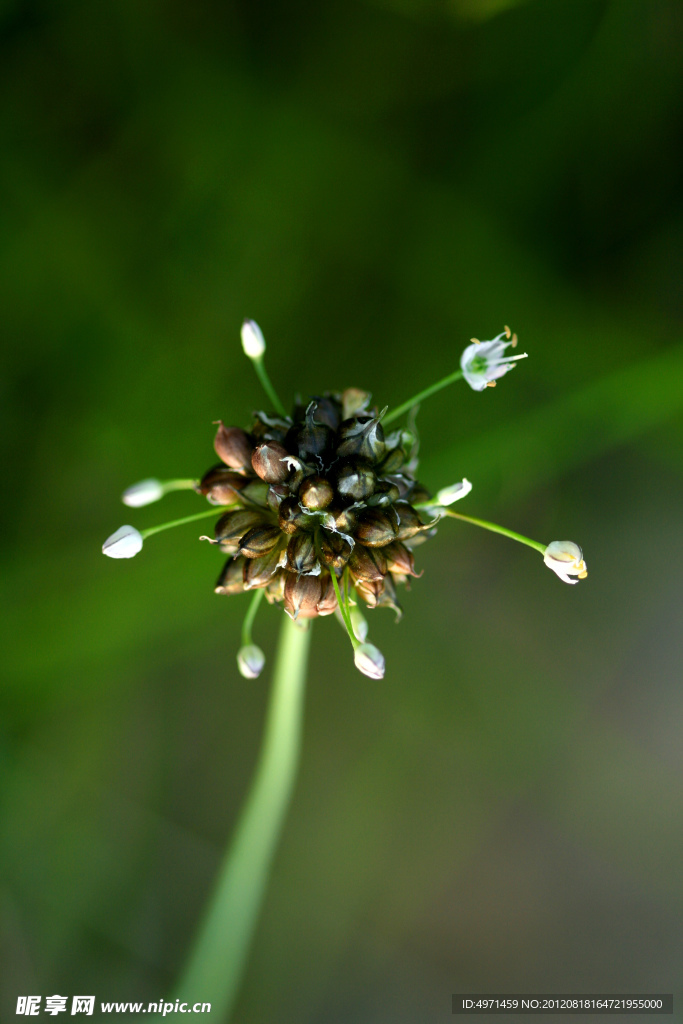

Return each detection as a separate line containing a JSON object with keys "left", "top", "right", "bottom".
{"left": 173, "top": 615, "right": 311, "bottom": 1024}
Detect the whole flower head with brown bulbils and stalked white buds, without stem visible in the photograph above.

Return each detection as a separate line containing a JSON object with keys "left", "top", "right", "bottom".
{"left": 102, "top": 321, "right": 588, "bottom": 679}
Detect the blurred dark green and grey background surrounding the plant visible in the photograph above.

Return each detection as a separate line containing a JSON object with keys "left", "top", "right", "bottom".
{"left": 0, "top": 0, "right": 683, "bottom": 1024}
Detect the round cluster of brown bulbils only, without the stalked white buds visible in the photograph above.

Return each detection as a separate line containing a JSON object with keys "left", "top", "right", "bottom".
{"left": 198, "top": 388, "right": 435, "bottom": 620}
